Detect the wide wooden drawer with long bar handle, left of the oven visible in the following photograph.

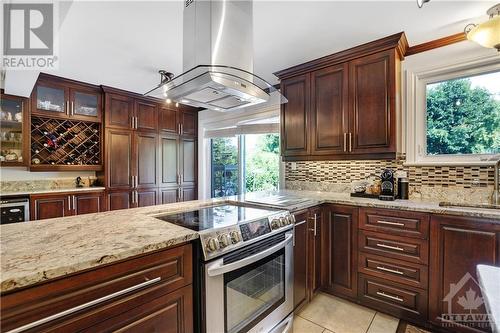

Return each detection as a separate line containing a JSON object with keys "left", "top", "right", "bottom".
{"left": 1, "top": 244, "right": 192, "bottom": 332}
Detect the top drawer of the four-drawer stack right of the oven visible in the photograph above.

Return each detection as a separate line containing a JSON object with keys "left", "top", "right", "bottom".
{"left": 359, "top": 208, "right": 429, "bottom": 239}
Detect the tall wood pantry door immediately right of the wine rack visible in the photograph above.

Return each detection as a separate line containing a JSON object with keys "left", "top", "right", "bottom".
{"left": 105, "top": 129, "right": 133, "bottom": 189}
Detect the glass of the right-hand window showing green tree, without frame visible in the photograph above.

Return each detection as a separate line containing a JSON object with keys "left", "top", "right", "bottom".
{"left": 426, "top": 71, "right": 500, "bottom": 155}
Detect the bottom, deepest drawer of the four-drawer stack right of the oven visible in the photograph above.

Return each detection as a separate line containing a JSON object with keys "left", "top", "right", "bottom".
{"left": 358, "top": 274, "right": 427, "bottom": 319}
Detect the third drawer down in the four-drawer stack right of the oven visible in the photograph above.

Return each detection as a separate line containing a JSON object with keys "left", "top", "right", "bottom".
{"left": 359, "top": 252, "right": 428, "bottom": 289}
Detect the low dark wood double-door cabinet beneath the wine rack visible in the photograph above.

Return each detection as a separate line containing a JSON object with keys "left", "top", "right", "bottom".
{"left": 30, "top": 191, "right": 105, "bottom": 220}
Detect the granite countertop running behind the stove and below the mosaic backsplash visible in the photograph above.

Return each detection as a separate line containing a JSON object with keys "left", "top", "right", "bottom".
{"left": 236, "top": 190, "right": 500, "bottom": 223}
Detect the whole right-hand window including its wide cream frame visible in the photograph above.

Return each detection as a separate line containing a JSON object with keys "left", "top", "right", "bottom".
{"left": 401, "top": 55, "right": 500, "bottom": 165}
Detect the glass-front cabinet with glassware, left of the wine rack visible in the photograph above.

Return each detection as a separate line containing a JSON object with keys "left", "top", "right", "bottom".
{"left": 0, "top": 94, "right": 27, "bottom": 166}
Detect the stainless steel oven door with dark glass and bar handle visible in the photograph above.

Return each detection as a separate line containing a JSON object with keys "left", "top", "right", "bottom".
{"left": 204, "top": 230, "right": 293, "bottom": 333}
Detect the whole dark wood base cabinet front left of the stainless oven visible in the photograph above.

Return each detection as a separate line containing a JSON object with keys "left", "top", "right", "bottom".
{"left": 0, "top": 244, "right": 193, "bottom": 333}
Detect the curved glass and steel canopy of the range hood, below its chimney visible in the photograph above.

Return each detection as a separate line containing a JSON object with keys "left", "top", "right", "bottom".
{"left": 145, "top": 65, "right": 287, "bottom": 111}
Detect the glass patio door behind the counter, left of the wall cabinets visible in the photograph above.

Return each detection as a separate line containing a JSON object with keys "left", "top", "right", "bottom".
{"left": 211, "top": 133, "right": 280, "bottom": 198}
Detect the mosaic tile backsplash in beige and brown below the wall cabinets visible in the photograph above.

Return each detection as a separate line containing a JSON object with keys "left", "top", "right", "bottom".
{"left": 285, "top": 155, "right": 494, "bottom": 203}
